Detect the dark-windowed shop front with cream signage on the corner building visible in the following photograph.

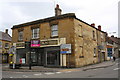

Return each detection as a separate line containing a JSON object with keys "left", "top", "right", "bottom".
{"left": 16, "top": 39, "right": 66, "bottom": 67}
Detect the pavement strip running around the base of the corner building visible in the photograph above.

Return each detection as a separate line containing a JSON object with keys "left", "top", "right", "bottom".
{"left": 2, "top": 61, "right": 115, "bottom": 72}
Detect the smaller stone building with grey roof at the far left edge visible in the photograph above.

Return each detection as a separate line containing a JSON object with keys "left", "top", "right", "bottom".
{"left": 0, "top": 29, "right": 12, "bottom": 63}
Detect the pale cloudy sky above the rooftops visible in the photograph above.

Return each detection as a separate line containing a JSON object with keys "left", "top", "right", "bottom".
{"left": 0, "top": 0, "right": 120, "bottom": 36}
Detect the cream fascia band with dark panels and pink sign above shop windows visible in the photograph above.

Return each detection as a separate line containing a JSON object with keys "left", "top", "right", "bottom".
{"left": 16, "top": 38, "right": 66, "bottom": 49}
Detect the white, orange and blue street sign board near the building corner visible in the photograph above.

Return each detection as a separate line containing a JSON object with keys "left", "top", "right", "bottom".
{"left": 60, "top": 44, "right": 71, "bottom": 54}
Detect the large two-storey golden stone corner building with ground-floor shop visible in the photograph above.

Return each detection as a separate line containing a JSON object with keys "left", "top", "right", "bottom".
{"left": 12, "top": 5, "right": 107, "bottom": 67}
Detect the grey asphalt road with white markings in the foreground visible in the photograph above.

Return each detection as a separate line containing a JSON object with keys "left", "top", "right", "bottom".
{"left": 2, "top": 62, "right": 120, "bottom": 78}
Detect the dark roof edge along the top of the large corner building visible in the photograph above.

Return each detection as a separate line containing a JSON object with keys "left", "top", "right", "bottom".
{"left": 11, "top": 13, "right": 106, "bottom": 33}
